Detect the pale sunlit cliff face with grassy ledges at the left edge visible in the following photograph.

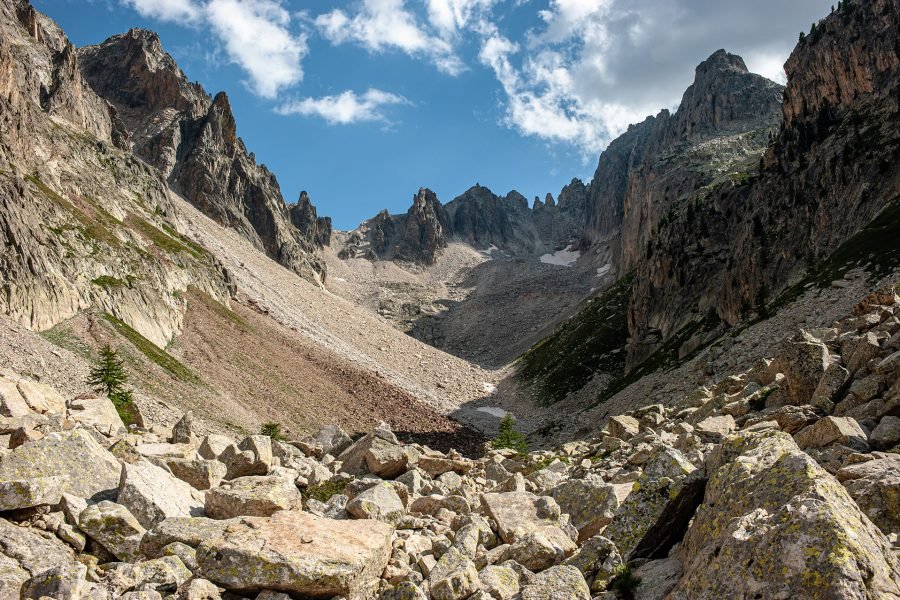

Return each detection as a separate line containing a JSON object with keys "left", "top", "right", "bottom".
{"left": 0, "top": 0, "right": 229, "bottom": 347}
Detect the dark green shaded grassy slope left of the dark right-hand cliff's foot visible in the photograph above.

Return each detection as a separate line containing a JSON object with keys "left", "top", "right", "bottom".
{"left": 516, "top": 273, "right": 634, "bottom": 404}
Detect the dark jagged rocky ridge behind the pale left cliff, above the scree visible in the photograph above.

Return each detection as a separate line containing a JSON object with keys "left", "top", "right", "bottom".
{"left": 78, "top": 29, "right": 325, "bottom": 281}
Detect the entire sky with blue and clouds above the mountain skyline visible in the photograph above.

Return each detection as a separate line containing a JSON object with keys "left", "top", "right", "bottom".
{"left": 33, "top": 0, "right": 830, "bottom": 229}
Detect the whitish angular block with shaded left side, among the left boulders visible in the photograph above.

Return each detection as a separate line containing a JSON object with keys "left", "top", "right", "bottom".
{"left": 118, "top": 461, "right": 203, "bottom": 529}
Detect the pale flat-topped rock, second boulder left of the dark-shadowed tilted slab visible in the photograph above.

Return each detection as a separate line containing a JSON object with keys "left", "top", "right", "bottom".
{"left": 481, "top": 492, "right": 561, "bottom": 544}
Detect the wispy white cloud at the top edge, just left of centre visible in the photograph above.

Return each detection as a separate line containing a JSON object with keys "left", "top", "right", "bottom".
{"left": 313, "top": 0, "right": 465, "bottom": 75}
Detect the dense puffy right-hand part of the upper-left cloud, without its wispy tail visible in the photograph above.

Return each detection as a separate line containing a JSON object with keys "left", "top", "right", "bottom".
{"left": 206, "top": 0, "right": 308, "bottom": 98}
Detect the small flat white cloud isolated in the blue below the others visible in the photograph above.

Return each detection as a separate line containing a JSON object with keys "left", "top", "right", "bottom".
{"left": 276, "top": 88, "right": 410, "bottom": 125}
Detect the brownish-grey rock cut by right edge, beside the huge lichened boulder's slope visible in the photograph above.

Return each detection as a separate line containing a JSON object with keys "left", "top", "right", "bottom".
{"left": 835, "top": 452, "right": 900, "bottom": 534}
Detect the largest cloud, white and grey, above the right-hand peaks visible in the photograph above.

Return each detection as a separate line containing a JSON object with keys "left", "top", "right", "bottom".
{"left": 479, "top": 0, "right": 828, "bottom": 156}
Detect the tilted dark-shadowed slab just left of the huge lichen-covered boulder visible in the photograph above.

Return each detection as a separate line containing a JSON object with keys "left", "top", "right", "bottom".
{"left": 603, "top": 446, "right": 702, "bottom": 558}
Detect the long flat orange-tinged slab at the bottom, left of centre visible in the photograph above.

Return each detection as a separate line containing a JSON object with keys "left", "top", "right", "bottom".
{"left": 197, "top": 511, "right": 393, "bottom": 599}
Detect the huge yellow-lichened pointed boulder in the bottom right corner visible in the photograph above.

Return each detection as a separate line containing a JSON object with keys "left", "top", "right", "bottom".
{"left": 672, "top": 431, "right": 900, "bottom": 600}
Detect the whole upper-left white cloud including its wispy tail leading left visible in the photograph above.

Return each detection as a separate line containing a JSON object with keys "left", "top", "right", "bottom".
{"left": 122, "top": 0, "right": 308, "bottom": 98}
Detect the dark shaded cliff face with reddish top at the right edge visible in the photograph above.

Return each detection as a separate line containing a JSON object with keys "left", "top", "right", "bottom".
{"left": 629, "top": 0, "right": 900, "bottom": 365}
